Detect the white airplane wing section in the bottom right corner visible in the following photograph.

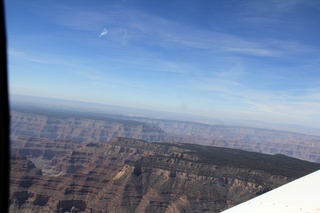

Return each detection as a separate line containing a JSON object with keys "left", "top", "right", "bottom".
{"left": 222, "top": 170, "right": 320, "bottom": 213}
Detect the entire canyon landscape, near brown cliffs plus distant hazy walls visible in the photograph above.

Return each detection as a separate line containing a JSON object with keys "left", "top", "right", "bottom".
{"left": 9, "top": 107, "right": 320, "bottom": 213}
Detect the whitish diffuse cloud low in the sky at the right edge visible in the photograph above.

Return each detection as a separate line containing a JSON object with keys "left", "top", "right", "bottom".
{"left": 197, "top": 75, "right": 320, "bottom": 119}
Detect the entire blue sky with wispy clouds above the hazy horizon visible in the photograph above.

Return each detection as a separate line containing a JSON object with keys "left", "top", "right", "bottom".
{"left": 5, "top": 0, "right": 320, "bottom": 128}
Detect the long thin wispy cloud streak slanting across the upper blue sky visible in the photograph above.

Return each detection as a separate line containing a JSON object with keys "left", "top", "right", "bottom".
{"left": 28, "top": 2, "right": 312, "bottom": 57}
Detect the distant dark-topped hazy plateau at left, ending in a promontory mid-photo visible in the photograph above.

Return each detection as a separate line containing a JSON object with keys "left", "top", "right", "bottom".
{"left": 11, "top": 108, "right": 164, "bottom": 143}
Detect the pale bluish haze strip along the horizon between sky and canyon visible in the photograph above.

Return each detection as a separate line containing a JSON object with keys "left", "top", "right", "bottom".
{"left": 10, "top": 94, "right": 320, "bottom": 135}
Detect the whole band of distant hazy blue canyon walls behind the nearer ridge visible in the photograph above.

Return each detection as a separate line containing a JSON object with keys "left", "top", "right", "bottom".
{"left": 11, "top": 108, "right": 320, "bottom": 163}
